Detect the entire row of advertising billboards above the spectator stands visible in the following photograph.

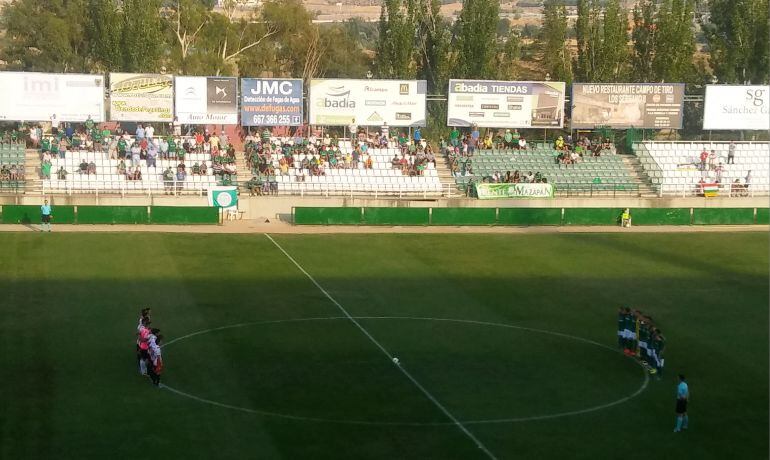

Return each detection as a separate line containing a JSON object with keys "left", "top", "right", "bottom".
{"left": 0, "top": 72, "right": 770, "bottom": 130}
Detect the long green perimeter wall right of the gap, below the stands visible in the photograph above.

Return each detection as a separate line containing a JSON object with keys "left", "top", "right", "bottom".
{"left": 294, "top": 207, "right": 770, "bottom": 226}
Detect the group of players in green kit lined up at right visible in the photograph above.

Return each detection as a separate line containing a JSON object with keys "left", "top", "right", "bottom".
{"left": 618, "top": 307, "right": 666, "bottom": 377}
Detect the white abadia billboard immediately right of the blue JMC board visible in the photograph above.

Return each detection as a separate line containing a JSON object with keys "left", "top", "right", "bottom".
{"left": 308, "top": 80, "right": 428, "bottom": 126}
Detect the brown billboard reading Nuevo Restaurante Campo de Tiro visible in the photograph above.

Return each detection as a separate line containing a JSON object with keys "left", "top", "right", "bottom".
{"left": 572, "top": 83, "right": 684, "bottom": 129}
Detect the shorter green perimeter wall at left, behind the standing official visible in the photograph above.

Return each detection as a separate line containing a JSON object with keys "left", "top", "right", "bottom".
{"left": 2, "top": 205, "right": 219, "bottom": 225}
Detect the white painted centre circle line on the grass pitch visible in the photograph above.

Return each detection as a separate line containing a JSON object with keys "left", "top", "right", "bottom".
{"left": 162, "top": 316, "right": 650, "bottom": 426}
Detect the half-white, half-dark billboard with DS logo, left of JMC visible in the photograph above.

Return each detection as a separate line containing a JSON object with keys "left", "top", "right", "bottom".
{"left": 174, "top": 77, "right": 238, "bottom": 125}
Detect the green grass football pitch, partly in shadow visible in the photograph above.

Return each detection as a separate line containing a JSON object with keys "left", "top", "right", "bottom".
{"left": 0, "top": 233, "right": 768, "bottom": 459}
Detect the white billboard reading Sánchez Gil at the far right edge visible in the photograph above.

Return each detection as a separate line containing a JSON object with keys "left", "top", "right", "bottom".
{"left": 703, "top": 85, "right": 770, "bottom": 131}
